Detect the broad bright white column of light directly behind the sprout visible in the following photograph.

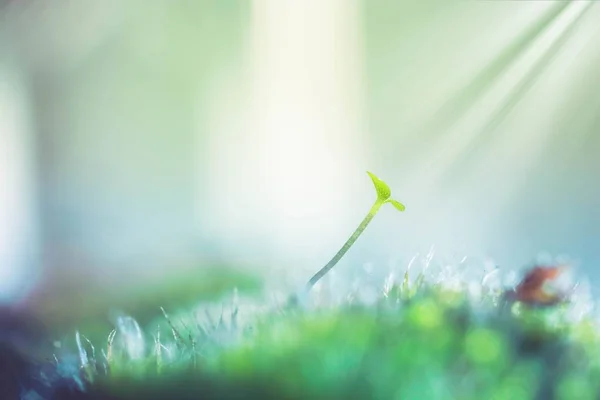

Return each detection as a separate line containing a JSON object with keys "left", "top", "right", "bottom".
{"left": 203, "top": 0, "right": 366, "bottom": 270}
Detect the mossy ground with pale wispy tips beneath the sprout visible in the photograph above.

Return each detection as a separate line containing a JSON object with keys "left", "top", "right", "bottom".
{"left": 28, "top": 260, "right": 600, "bottom": 400}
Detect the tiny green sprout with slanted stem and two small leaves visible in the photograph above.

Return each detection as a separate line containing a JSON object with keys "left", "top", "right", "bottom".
{"left": 306, "top": 171, "right": 405, "bottom": 290}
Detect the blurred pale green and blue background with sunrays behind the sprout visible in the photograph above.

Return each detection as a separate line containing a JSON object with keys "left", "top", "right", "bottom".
{"left": 0, "top": 0, "right": 600, "bottom": 330}
